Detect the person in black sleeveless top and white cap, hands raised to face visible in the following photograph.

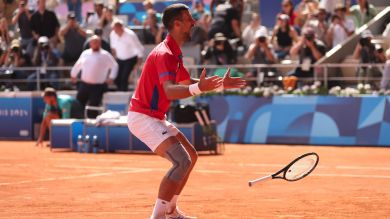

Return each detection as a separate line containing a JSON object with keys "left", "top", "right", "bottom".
{"left": 271, "top": 14, "right": 298, "bottom": 60}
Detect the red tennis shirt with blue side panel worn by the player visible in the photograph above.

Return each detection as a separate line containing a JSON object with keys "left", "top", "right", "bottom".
{"left": 129, "top": 35, "right": 190, "bottom": 120}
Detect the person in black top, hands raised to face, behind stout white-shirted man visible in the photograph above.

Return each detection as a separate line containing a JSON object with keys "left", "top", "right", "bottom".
{"left": 59, "top": 12, "right": 87, "bottom": 65}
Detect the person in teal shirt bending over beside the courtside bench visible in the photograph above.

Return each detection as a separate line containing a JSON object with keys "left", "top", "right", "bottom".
{"left": 36, "top": 87, "right": 83, "bottom": 146}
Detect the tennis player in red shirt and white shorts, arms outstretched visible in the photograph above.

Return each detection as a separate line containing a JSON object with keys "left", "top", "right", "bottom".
{"left": 128, "top": 4, "right": 245, "bottom": 219}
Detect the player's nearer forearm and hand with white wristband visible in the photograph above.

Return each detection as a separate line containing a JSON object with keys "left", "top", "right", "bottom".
{"left": 163, "top": 69, "right": 224, "bottom": 100}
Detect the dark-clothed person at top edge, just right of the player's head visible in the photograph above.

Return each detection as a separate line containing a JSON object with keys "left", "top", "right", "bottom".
{"left": 208, "top": 0, "right": 241, "bottom": 39}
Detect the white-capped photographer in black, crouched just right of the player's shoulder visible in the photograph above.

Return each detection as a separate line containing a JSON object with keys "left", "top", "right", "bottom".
{"left": 201, "top": 33, "right": 237, "bottom": 65}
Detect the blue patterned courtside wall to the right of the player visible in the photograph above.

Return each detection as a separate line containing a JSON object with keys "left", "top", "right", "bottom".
{"left": 197, "top": 95, "right": 390, "bottom": 146}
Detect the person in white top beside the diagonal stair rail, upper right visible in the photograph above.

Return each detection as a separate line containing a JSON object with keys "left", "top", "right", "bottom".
{"left": 326, "top": 5, "right": 355, "bottom": 48}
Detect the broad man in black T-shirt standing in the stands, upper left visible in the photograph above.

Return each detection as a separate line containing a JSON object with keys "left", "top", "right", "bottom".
{"left": 31, "top": 0, "right": 60, "bottom": 49}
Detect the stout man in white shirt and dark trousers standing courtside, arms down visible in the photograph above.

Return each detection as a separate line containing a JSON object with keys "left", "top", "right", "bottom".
{"left": 70, "top": 35, "right": 118, "bottom": 118}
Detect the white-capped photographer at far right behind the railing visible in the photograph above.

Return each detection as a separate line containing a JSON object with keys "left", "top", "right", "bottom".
{"left": 353, "top": 30, "right": 386, "bottom": 83}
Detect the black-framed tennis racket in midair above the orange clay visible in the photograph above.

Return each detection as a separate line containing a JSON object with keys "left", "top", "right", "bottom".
{"left": 249, "top": 152, "right": 320, "bottom": 186}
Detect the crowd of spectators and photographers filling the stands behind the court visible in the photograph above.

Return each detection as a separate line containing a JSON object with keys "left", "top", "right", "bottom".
{"left": 0, "top": 0, "right": 390, "bottom": 91}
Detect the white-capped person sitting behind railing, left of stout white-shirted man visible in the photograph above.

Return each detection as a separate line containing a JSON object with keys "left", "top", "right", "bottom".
{"left": 27, "top": 36, "right": 59, "bottom": 90}
